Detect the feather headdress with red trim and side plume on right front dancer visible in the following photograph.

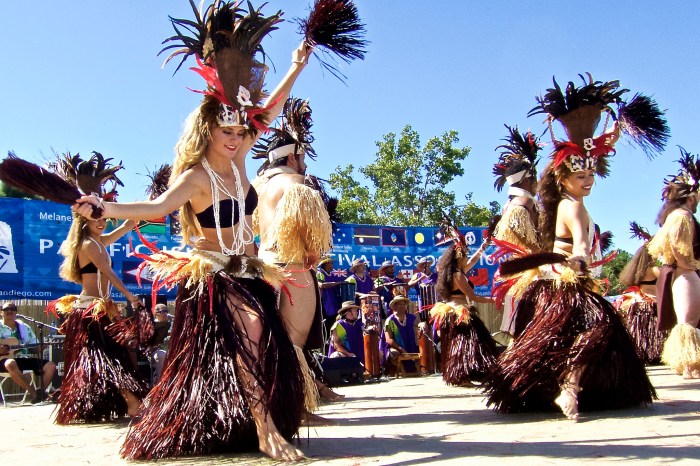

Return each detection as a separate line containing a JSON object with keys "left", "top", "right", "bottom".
{"left": 528, "top": 73, "right": 669, "bottom": 177}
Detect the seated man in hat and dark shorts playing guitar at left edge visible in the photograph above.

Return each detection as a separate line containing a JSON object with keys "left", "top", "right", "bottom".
{"left": 0, "top": 302, "right": 56, "bottom": 404}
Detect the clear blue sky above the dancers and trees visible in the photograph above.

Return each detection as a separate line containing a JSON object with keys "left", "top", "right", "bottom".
{"left": 0, "top": 0, "right": 700, "bottom": 255}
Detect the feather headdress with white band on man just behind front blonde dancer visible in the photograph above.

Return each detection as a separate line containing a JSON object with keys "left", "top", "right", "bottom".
{"left": 253, "top": 97, "right": 316, "bottom": 163}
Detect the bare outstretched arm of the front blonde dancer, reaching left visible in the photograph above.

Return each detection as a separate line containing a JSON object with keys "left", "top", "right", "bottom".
{"left": 73, "top": 170, "right": 200, "bottom": 220}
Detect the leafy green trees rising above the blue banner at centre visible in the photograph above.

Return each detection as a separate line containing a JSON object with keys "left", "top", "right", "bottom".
{"left": 330, "top": 125, "right": 500, "bottom": 226}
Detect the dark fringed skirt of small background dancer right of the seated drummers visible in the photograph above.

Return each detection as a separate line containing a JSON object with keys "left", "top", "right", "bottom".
{"left": 435, "top": 303, "right": 499, "bottom": 386}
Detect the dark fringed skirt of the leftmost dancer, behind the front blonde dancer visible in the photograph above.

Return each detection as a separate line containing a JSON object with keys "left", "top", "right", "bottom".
{"left": 55, "top": 302, "right": 148, "bottom": 425}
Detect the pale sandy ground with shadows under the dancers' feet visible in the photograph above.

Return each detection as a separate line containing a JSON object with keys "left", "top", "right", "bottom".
{"left": 0, "top": 367, "right": 700, "bottom": 466}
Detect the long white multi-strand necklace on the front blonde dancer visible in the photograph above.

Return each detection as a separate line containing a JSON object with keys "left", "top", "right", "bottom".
{"left": 201, "top": 157, "right": 253, "bottom": 256}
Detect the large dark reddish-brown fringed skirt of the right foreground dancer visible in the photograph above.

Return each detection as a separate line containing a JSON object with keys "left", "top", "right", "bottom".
{"left": 484, "top": 280, "right": 656, "bottom": 413}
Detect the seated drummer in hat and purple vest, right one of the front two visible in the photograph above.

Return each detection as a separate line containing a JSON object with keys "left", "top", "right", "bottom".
{"left": 380, "top": 296, "right": 425, "bottom": 373}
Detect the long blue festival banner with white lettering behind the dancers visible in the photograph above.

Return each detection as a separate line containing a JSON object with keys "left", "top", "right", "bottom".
{"left": 0, "top": 198, "right": 497, "bottom": 300}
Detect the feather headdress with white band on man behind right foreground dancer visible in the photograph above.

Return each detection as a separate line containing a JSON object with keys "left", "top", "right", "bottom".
{"left": 493, "top": 125, "right": 540, "bottom": 192}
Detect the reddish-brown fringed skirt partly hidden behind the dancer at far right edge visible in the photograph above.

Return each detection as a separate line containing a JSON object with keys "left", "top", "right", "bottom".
{"left": 627, "top": 300, "right": 669, "bottom": 364}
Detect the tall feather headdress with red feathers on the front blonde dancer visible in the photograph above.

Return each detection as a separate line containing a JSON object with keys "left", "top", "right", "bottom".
{"left": 161, "top": 0, "right": 282, "bottom": 131}
